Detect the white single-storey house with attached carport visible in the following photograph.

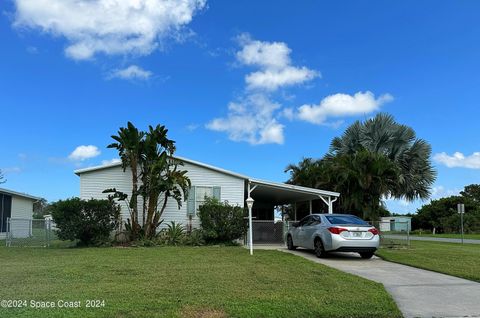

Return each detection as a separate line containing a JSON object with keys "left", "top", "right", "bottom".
{"left": 75, "top": 157, "right": 339, "bottom": 241}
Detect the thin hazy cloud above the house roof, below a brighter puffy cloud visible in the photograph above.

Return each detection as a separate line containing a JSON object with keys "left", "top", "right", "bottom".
{"left": 206, "top": 94, "right": 284, "bottom": 145}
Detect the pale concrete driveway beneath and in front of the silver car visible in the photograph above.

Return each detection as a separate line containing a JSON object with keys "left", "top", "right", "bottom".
{"left": 279, "top": 248, "right": 480, "bottom": 317}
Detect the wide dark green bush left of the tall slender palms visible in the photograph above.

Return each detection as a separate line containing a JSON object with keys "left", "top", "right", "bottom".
{"left": 50, "top": 198, "right": 120, "bottom": 246}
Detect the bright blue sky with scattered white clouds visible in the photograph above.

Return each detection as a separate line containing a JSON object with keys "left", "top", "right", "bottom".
{"left": 0, "top": 0, "right": 480, "bottom": 213}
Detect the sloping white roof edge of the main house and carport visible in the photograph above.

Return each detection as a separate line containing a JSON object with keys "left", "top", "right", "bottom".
{"left": 75, "top": 156, "right": 340, "bottom": 198}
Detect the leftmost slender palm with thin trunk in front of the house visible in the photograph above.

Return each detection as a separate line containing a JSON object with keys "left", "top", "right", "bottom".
{"left": 107, "top": 122, "right": 145, "bottom": 239}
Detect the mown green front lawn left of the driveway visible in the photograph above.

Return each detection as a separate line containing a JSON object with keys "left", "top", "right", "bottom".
{"left": 0, "top": 247, "right": 401, "bottom": 317}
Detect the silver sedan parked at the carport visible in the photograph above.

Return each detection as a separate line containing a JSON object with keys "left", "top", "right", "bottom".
{"left": 287, "top": 214, "right": 380, "bottom": 258}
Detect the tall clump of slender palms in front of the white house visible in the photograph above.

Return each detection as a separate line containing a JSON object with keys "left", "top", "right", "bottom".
{"left": 104, "top": 122, "right": 191, "bottom": 240}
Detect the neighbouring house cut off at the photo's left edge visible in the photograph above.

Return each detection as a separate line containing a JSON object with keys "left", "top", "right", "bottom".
{"left": 0, "top": 188, "right": 40, "bottom": 238}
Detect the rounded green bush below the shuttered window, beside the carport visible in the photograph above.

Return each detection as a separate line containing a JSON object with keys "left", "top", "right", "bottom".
{"left": 198, "top": 198, "right": 246, "bottom": 243}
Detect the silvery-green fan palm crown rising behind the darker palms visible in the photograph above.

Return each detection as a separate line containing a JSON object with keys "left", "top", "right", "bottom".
{"left": 328, "top": 114, "right": 436, "bottom": 201}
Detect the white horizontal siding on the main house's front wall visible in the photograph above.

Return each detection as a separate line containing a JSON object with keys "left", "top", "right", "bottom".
{"left": 80, "top": 163, "right": 245, "bottom": 227}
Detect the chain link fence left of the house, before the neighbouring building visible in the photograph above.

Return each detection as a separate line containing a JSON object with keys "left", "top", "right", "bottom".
{"left": 5, "top": 218, "right": 57, "bottom": 247}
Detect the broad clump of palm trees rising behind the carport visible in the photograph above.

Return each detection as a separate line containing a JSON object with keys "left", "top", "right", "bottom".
{"left": 286, "top": 114, "right": 436, "bottom": 220}
